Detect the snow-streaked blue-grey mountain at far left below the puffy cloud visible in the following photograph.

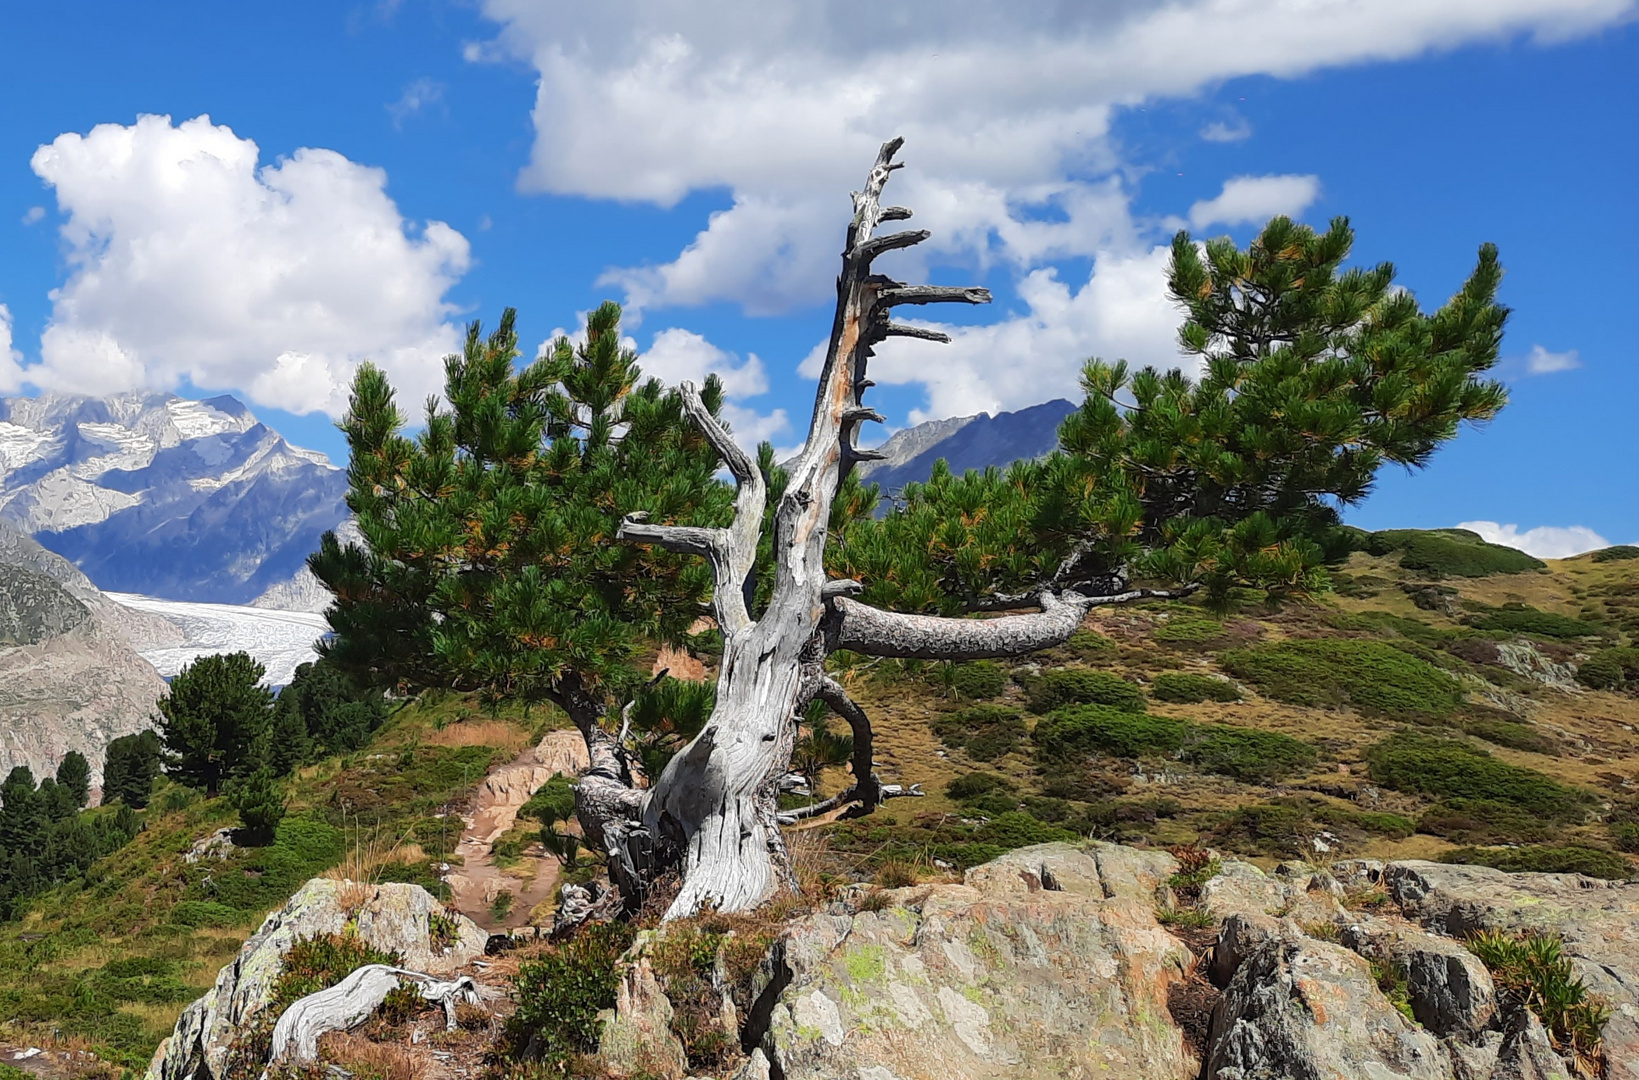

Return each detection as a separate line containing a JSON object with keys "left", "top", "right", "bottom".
{"left": 0, "top": 392, "right": 347, "bottom": 605}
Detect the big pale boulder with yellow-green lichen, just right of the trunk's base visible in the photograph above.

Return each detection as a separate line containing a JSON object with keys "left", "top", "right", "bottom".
{"left": 752, "top": 844, "right": 1200, "bottom": 1080}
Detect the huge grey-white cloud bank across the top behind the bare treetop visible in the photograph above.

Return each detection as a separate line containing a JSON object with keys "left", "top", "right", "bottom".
{"left": 465, "top": 0, "right": 1634, "bottom": 426}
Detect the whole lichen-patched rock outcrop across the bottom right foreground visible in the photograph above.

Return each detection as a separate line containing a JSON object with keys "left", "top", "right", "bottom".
{"left": 603, "top": 844, "right": 1639, "bottom": 1080}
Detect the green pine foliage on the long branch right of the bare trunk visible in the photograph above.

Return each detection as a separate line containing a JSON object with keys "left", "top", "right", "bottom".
{"left": 829, "top": 218, "right": 1508, "bottom": 618}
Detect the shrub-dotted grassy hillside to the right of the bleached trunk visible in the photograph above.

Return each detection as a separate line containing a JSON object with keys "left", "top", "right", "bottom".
{"left": 826, "top": 529, "right": 1639, "bottom": 875}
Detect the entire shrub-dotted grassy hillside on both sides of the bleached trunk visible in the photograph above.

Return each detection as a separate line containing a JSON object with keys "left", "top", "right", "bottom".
{"left": 0, "top": 531, "right": 1639, "bottom": 1065}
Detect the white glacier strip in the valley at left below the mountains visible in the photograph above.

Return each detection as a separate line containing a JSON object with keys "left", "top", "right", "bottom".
{"left": 107, "top": 593, "right": 329, "bottom": 687}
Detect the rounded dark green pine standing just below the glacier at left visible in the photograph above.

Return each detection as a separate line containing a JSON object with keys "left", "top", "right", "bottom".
{"left": 159, "top": 652, "right": 272, "bottom": 798}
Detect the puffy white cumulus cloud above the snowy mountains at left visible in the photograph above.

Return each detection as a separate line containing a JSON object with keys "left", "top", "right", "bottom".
{"left": 21, "top": 116, "right": 470, "bottom": 416}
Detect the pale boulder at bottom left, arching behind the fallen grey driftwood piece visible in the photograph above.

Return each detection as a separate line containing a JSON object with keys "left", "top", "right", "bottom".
{"left": 148, "top": 878, "right": 488, "bottom": 1080}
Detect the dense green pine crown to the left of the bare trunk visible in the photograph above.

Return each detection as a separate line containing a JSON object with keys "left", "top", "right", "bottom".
{"left": 308, "top": 303, "right": 729, "bottom": 729}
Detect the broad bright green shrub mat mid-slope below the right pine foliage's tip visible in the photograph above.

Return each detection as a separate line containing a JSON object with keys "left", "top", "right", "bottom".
{"left": 1218, "top": 639, "right": 1462, "bottom": 716}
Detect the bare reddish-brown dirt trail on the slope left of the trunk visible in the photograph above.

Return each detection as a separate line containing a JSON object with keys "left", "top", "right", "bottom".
{"left": 444, "top": 731, "right": 588, "bottom": 933}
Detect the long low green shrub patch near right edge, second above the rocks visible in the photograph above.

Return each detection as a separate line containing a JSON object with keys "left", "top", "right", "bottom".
{"left": 1367, "top": 733, "right": 1593, "bottom": 823}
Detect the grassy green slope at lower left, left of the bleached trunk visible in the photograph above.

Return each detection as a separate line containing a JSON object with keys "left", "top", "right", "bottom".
{"left": 0, "top": 693, "right": 552, "bottom": 1067}
